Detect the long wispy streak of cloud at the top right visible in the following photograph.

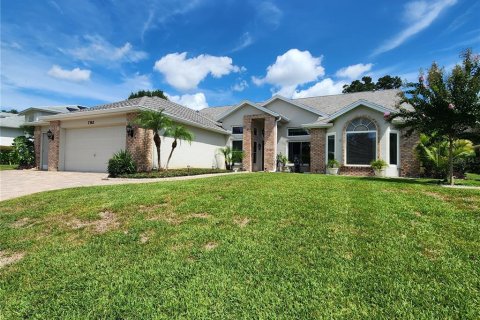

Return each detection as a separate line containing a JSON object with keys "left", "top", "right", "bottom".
{"left": 372, "top": 0, "right": 457, "bottom": 55}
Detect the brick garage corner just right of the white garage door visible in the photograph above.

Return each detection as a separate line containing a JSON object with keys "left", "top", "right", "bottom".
{"left": 125, "top": 112, "right": 153, "bottom": 172}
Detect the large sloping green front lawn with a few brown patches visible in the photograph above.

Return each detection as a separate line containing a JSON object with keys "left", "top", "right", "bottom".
{"left": 0, "top": 173, "right": 480, "bottom": 319}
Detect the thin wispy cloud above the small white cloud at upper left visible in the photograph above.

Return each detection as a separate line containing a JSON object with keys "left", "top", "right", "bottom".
{"left": 67, "top": 35, "right": 148, "bottom": 63}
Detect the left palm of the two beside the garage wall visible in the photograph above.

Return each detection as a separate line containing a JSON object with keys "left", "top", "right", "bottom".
{"left": 134, "top": 110, "right": 172, "bottom": 171}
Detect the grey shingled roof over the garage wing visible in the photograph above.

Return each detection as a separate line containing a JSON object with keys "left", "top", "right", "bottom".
{"left": 77, "top": 97, "right": 227, "bottom": 132}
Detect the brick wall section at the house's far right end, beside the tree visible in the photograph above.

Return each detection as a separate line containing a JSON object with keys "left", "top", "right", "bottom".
{"left": 400, "top": 131, "right": 420, "bottom": 177}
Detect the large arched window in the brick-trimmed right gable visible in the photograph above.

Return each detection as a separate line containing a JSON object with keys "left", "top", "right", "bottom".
{"left": 346, "top": 118, "right": 377, "bottom": 165}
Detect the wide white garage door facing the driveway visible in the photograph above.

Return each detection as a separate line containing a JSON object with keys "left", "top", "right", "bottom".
{"left": 65, "top": 126, "right": 126, "bottom": 172}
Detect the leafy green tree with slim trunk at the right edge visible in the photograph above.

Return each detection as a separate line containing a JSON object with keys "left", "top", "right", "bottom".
{"left": 385, "top": 49, "right": 480, "bottom": 185}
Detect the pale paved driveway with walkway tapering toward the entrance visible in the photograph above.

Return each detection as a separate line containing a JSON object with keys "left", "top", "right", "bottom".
{"left": 0, "top": 170, "right": 240, "bottom": 201}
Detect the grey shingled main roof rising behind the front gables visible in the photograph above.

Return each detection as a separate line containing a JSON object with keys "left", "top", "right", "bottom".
{"left": 200, "top": 89, "right": 401, "bottom": 120}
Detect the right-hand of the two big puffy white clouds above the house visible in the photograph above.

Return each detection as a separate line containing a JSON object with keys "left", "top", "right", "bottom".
{"left": 252, "top": 49, "right": 325, "bottom": 97}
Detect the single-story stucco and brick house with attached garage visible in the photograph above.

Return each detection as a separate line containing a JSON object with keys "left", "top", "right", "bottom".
{"left": 33, "top": 90, "right": 419, "bottom": 176}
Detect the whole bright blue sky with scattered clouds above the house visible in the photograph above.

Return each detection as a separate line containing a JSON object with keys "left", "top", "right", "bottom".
{"left": 0, "top": 0, "right": 480, "bottom": 109}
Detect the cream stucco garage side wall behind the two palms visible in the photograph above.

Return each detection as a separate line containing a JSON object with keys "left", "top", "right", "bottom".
{"left": 153, "top": 125, "right": 228, "bottom": 169}
